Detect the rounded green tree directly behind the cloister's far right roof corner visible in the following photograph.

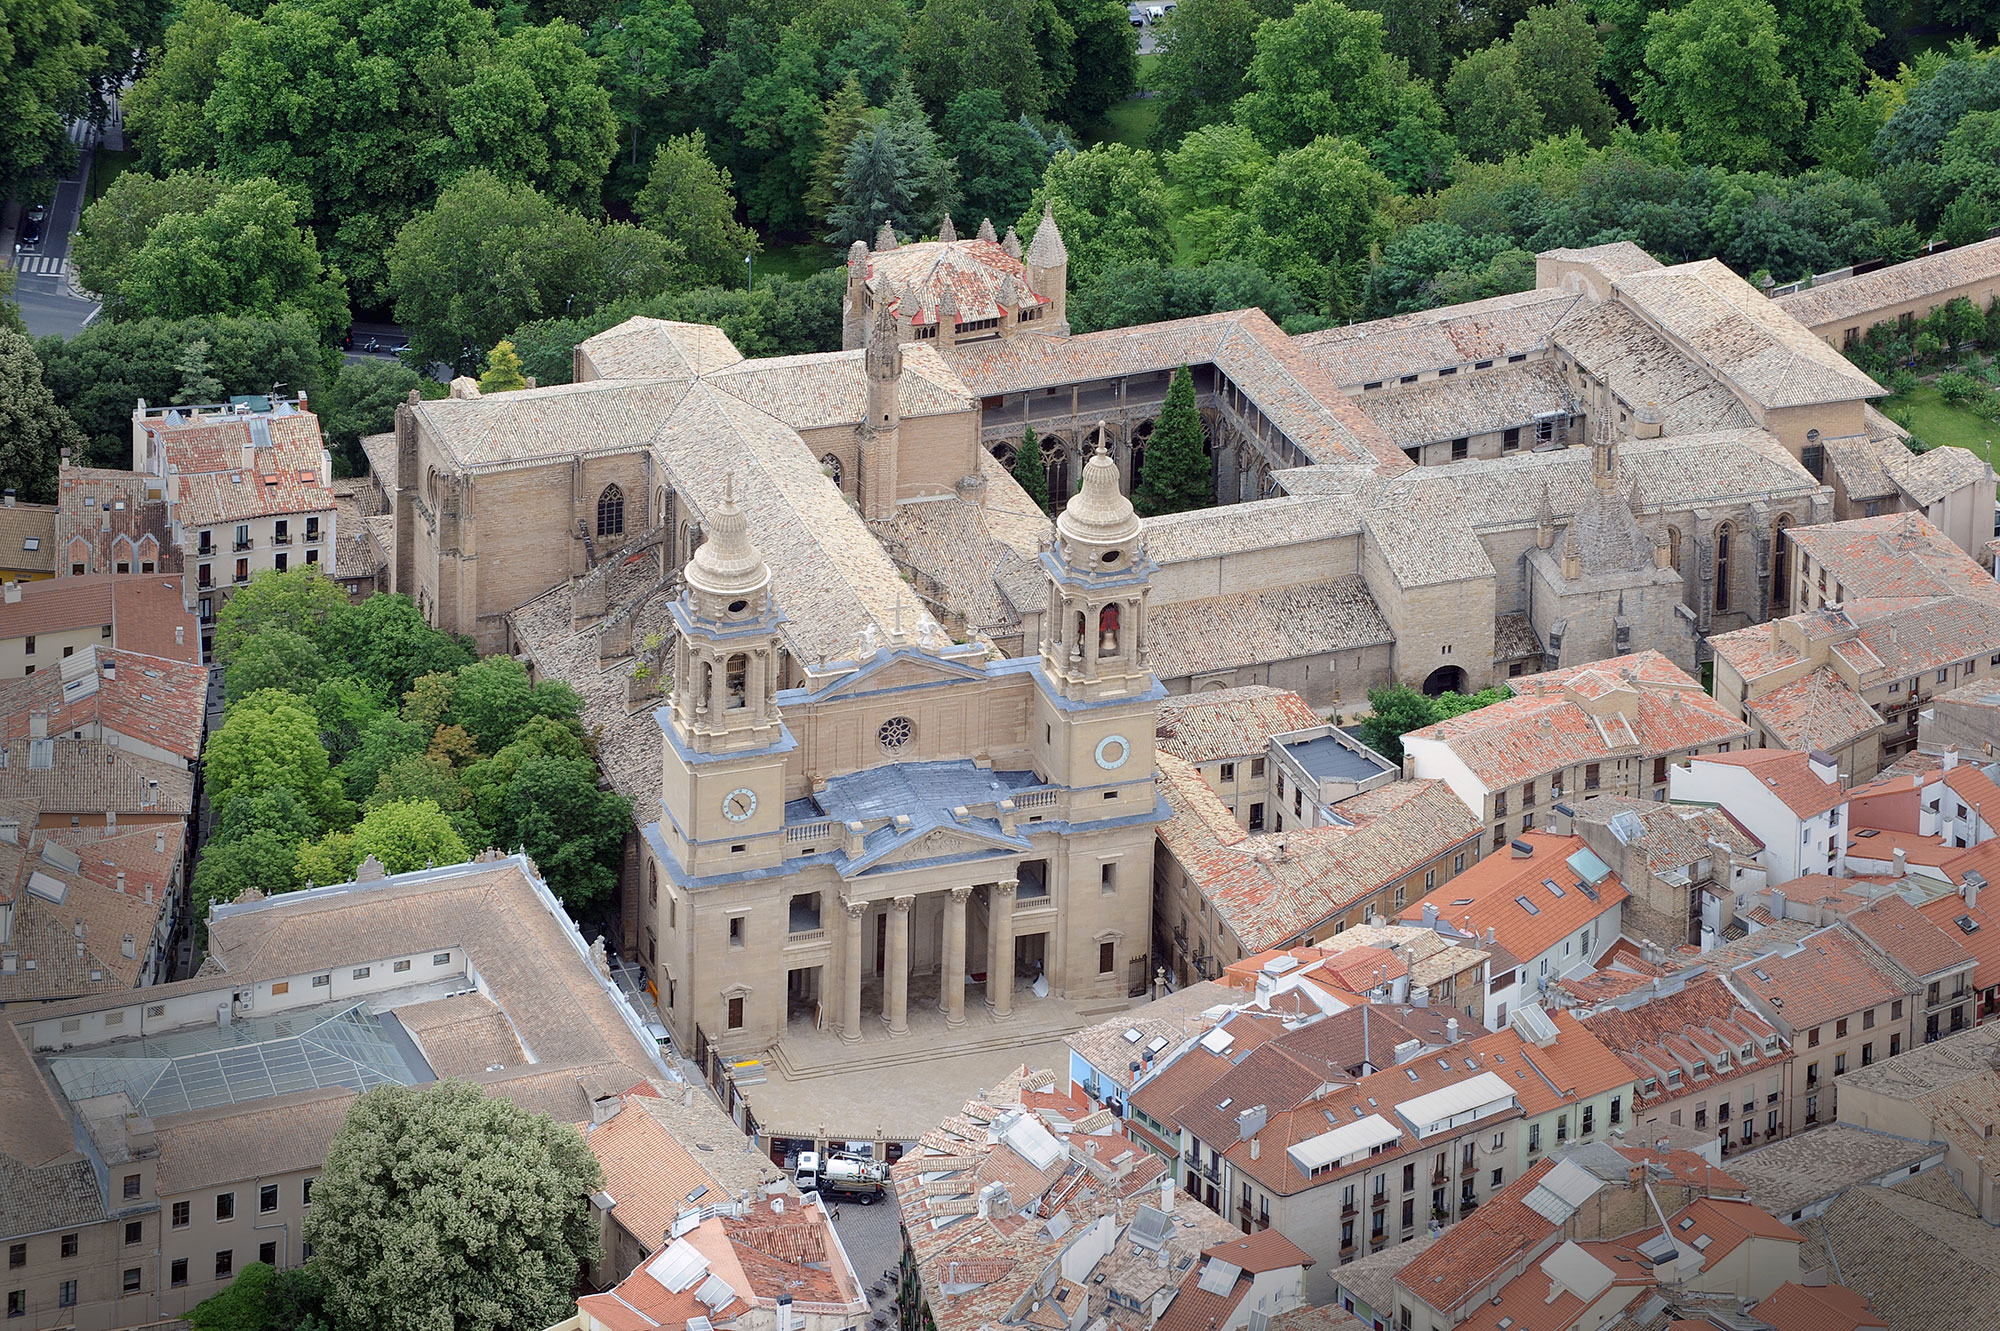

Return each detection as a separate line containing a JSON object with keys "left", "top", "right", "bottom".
{"left": 1244, "top": 138, "right": 1392, "bottom": 316}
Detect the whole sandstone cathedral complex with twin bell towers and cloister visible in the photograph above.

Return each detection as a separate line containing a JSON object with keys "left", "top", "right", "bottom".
{"left": 368, "top": 216, "right": 1994, "bottom": 1057}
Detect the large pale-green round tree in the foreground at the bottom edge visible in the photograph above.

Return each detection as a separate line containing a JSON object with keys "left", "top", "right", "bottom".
{"left": 304, "top": 1081, "right": 604, "bottom": 1331}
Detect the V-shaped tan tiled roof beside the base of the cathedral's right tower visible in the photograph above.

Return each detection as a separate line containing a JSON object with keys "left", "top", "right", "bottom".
{"left": 1160, "top": 753, "right": 1480, "bottom": 953}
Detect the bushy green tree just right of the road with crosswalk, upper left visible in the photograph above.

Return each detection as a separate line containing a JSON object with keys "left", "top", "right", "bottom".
{"left": 106, "top": 180, "right": 348, "bottom": 338}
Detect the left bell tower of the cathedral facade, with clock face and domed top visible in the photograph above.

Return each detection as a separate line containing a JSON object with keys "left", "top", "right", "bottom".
{"left": 656, "top": 476, "right": 792, "bottom": 875}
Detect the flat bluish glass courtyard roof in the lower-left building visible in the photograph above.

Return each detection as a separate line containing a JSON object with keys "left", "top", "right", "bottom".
{"left": 48, "top": 1003, "right": 430, "bottom": 1117}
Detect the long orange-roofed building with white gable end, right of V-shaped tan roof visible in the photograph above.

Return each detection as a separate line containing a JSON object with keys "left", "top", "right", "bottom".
{"left": 1402, "top": 652, "right": 1750, "bottom": 851}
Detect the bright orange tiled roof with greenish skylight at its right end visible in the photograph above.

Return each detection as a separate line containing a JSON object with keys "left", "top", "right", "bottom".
{"left": 1402, "top": 831, "right": 1626, "bottom": 961}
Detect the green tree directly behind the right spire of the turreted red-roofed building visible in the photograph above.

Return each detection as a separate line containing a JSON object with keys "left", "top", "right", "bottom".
{"left": 1018, "top": 144, "right": 1174, "bottom": 284}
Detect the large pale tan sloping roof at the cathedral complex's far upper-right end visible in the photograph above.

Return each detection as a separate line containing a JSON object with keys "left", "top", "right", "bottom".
{"left": 1614, "top": 260, "right": 1888, "bottom": 410}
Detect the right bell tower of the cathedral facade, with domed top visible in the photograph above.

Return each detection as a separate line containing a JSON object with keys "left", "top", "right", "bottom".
{"left": 1040, "top": 424, "right": 1160, "bottom": 791}
